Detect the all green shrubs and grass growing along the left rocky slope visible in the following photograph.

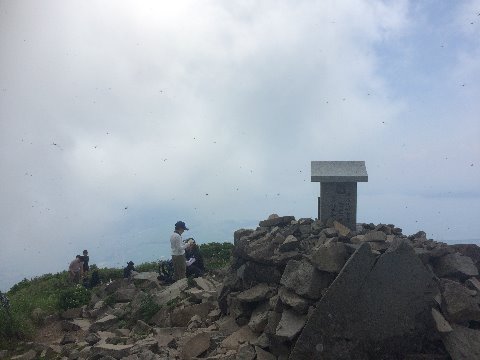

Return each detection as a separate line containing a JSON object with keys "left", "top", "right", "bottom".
{"left": 0, "top": 243, "right": 233, "bottom": 349}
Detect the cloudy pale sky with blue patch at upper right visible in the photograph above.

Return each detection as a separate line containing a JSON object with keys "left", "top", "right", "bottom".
{"left": 0, "top": 0, "right": 480, "bottom": 290}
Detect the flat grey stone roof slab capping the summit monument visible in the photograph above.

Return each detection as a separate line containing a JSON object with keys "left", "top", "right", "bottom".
{"left": 312, "top": 161, "right": 368, "bottom": 182}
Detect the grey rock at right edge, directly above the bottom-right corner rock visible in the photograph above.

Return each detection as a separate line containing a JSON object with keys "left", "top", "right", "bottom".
{"left": 440, "top": 279, "right": 480, "bottom": 323}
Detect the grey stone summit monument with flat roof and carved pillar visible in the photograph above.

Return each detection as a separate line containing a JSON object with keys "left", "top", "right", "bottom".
{"left": 311, "top": 161, "right": 368, "bottom": 231}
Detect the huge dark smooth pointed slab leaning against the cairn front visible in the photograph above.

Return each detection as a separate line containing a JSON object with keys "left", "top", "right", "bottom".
{"left": 290, "top": 241, "right": 438, "bottom": 359}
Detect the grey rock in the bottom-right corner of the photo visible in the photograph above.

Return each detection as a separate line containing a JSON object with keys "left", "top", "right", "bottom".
{"left": 442, "top": 325, "right": 480, "bottom": 360}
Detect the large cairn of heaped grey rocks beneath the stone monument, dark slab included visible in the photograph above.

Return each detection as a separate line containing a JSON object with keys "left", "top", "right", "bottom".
{"left": 219, "top": 215, "right": 480, "bottom": 360}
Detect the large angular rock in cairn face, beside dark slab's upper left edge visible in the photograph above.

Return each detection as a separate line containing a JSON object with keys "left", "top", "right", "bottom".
{"left": 280, "top": 259, "right": 334, "bottom": 299}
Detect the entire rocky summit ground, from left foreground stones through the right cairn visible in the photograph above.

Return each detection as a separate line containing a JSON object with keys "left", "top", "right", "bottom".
{"left": 5, "top": 215, "right": 480, "bottom": 360}
